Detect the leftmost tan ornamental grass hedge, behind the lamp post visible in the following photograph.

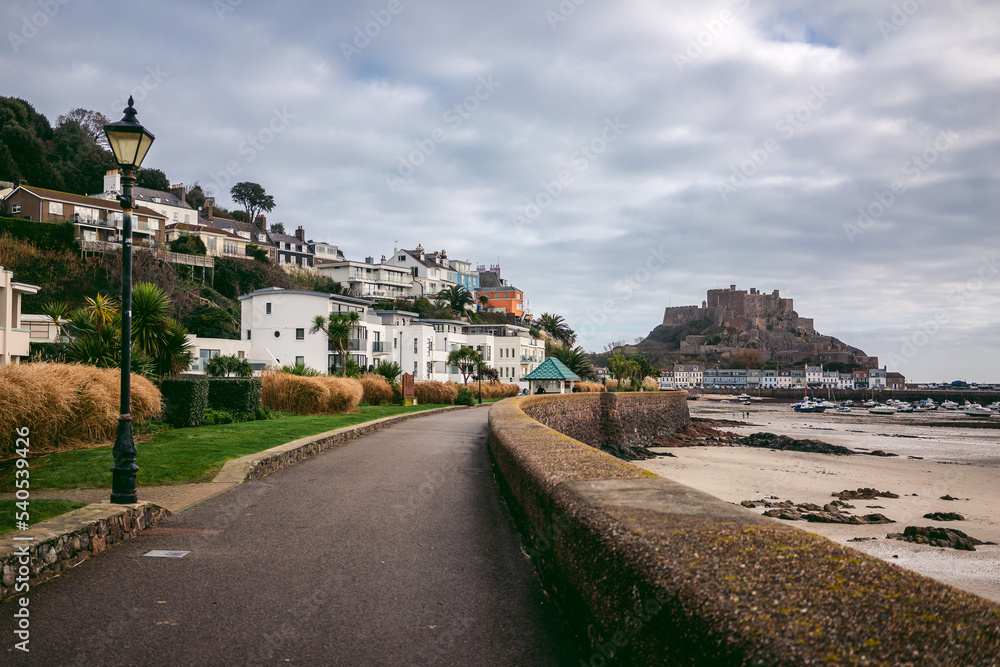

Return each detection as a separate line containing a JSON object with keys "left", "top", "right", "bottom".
{"left": 0, "top": 362, "right": 162, "bottom": 457}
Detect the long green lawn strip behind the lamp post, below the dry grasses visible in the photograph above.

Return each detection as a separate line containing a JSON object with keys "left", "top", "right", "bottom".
{"left": 0, "top": 405, "right": 444, "bottom": 494}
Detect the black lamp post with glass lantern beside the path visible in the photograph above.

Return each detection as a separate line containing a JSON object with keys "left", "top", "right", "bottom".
{"left": 104, "top": 96, "right": 155, "bottom": 504}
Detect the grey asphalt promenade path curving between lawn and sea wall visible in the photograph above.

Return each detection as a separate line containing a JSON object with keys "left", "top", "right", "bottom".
{"left": 0, "top": 408, "right": 578, "bottom": 666}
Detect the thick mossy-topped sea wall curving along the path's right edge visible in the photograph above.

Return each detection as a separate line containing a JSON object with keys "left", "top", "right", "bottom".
{"left": 489, "top": 394, "right": 1000, "bottom": 667}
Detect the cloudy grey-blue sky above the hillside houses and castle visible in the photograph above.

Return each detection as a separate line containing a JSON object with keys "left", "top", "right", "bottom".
{"left": 0, "top": 0, "right": 1000, "bottom": 381}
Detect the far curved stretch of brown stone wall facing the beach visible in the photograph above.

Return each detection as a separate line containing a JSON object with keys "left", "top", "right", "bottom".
{"left": 524, "top": 391, "right": 691, "bottom": 459}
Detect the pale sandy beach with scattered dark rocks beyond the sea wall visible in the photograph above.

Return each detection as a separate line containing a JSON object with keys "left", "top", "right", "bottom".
{"left": 637, "top": 397, "right": 1000, "bottom": 602}
